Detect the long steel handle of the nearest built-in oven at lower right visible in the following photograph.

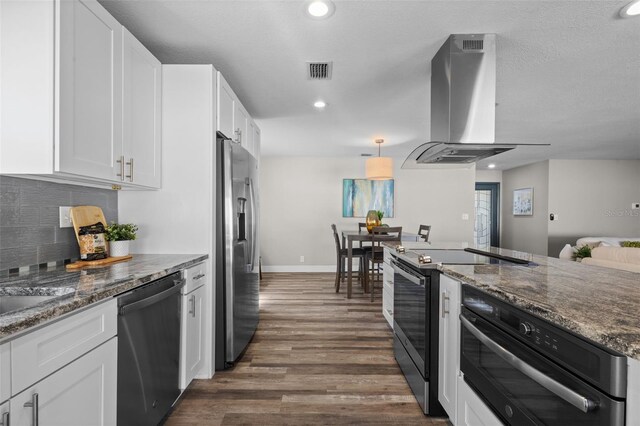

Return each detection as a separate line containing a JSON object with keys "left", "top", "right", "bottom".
{"left": 460, "top": 314, "right": 598, "bottom": 413}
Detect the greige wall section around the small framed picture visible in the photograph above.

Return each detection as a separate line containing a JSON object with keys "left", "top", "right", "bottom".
{"left": 501, "top": 161, "right": 549, "bottom": 256}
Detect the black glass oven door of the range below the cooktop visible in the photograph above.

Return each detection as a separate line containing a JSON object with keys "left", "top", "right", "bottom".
{"left": 391, "top": 260, "right": 429, "bottom": 379}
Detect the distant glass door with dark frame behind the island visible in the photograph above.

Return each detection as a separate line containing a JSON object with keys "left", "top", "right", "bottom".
{"left": 473, "top": 183, "right": 500, "bottom": 248}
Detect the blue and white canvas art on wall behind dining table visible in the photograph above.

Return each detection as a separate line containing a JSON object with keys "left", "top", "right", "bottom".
{"left": 342, "top": 179, "right": 393, "bottom": 217}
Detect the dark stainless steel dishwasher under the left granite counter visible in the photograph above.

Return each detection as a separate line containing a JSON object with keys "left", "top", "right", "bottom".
{"left": 118, "top": 273, "right": 185, "bottom": 425}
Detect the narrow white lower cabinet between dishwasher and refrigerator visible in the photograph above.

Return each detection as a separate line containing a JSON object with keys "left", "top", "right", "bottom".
{"left": 180, "top": 263, "right": 208, "bottom": 390}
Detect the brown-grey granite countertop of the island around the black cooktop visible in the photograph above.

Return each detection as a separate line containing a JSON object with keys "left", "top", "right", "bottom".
{"left": 384, "top": 243, "right": 640, "bottom": 360}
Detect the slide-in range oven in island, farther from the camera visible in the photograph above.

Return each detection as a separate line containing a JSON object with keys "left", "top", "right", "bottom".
{"left": 392, "top": 258, "right": 445, "bottom": 416}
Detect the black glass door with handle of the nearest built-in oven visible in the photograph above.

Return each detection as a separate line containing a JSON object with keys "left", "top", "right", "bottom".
{"left": 460, "top": 308, "right": 625, "bottom": 426}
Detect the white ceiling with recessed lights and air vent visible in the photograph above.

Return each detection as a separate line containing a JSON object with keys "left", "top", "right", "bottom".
{"left": 100, "top": 0, "right": 640, "bottom": 169}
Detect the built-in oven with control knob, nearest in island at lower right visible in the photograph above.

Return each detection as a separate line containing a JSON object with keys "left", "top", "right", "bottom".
{"left": 460, "top": 285, "right": 626, "bottom": 426}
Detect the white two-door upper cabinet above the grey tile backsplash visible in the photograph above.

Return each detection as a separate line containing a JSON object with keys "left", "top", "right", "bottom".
{"left": 0, "top": 0, "right": 161, "bottom": 187}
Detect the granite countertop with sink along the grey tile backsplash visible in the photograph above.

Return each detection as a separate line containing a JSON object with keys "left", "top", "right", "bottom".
{"left": 0, "top": 254, "right": 208, "bottom": 341}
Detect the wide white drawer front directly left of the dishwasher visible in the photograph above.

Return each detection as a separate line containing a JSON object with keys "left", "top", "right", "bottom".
{"left": 10, "top": 299, "right": 118, "bottom": 395}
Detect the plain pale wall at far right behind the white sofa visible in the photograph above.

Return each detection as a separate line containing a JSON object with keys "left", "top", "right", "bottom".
{"left": 548, "top": 160, "right": 640, "bottom": 256}
